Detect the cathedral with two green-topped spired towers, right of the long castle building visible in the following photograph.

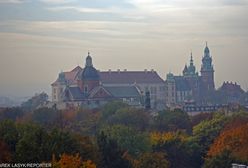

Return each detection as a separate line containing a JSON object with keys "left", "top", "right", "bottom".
{"left": 165, "top": 43, "right": 215, "bottom": 107}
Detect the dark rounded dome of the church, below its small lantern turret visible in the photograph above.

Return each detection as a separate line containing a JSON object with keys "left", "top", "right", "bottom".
{"left": 81, "top": 66, "right": 100, "bottom": 80}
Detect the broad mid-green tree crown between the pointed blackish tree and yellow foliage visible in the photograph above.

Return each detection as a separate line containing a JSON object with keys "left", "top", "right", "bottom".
{"left": 99, "top": 125, "right": 151, "bottom": 156}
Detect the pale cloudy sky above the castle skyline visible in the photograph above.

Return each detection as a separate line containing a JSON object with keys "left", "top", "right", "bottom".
{"left": 0, "top": 0, "right": 248, "bottom": 96}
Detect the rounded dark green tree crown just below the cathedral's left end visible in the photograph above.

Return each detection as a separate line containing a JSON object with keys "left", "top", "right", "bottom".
{"left": 153, "top": 109, "right": 192, "bottom": 133}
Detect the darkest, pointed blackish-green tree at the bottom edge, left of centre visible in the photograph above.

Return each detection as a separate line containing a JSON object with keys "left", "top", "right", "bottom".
{"left": 97, "top": 132, "right": 131, "bottom": 168}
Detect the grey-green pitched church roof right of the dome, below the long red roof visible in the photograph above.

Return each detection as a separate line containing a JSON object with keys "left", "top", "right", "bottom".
{"left": 104, "top": 86, "right": 140, "bottom": 98}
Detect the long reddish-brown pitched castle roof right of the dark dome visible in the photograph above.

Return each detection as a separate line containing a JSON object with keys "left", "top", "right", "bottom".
{"left": 100, "top": 71, "right": 164, "bottom": 84}
